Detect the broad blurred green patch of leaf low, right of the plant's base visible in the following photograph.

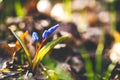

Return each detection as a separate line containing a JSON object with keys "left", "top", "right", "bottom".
{"left": 42, "top": 55, "right": 73, "bottom": 80}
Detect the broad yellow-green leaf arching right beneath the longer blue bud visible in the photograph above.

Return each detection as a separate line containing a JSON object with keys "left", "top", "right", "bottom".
{"left": 33, "top": 36, "right": 68, "bottom": 68}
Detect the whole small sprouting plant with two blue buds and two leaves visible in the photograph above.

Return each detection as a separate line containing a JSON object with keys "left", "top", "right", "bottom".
{"left": 9, "top": 24, "right": 68, "bottom": 80}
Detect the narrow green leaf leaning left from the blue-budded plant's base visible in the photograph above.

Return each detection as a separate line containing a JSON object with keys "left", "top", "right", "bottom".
{"left": 10, "top": 29, "right": 32, "bottom": 66}
